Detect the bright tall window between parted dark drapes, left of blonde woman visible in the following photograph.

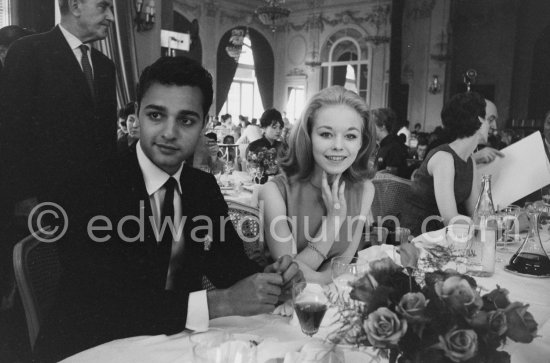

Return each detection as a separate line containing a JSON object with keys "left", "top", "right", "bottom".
{"left": 220, "top": 34, "right": 264, "bottom": 119}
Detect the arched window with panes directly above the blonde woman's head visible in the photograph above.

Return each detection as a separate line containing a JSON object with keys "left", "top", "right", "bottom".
{"left": 321, "top": 29, "right": 371, "bottom": 101}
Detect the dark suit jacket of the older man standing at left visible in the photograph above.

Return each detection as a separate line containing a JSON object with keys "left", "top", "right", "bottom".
{"left": 0, "top": 27, "right": 117, "bottom": 205}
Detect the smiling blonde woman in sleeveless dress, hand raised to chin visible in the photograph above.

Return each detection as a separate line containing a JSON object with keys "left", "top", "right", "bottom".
{"left": 259, "top": 86, "right": 375, "bottom": 284}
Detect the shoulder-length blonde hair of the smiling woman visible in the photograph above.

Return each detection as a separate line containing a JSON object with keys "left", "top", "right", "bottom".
{"left": 280, "top": 86, "right": 376, "bottom": 183}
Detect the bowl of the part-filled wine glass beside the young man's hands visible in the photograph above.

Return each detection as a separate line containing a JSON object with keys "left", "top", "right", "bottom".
{"left": 292, "top": 282, "right": 328, "bottom": 337}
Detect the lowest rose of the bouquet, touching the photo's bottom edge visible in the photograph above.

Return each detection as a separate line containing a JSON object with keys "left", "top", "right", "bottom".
{"left": 439, "top": 329, "right": 477, "bottom": 362}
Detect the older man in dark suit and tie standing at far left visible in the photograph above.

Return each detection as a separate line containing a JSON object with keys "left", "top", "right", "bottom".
{"left": 0, "top": 0, "right": 116, "bottom": 308}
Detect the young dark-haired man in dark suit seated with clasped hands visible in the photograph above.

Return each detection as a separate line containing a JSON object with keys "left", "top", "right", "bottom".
{"left": 36, "top": 58, "right": 302, "bottom": 361}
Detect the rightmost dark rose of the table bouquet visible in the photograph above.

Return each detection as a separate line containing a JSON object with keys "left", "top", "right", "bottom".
{"left": 504, "top": 302, "right": 538, "bottom": 343}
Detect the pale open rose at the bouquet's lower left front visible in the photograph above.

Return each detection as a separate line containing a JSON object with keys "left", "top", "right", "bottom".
{"left": 363, "top": 307, "right": 407, "bottom": 348}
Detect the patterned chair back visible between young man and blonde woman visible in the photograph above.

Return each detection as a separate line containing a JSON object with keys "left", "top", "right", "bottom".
{"left": 202, "top": 200, "right": 268, "bottom": 290}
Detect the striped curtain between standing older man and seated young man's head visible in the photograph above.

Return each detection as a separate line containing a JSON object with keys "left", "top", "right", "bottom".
{"left": 95, "top": 0, "right": 138, "bottom": 108}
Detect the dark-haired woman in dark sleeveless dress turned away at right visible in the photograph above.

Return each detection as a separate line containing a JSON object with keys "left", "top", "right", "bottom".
{"left": 401, "top": 92, "right": 500, "bottom": 236}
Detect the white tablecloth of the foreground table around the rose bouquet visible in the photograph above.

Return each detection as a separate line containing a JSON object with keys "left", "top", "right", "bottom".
{"left": 63, "top": 229, "right": 550, "bottom": 363}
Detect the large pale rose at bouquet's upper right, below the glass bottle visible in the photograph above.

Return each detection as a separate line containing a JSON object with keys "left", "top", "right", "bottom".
{"left": 435, "top": 276, "right": 483, "bottom": 316}
